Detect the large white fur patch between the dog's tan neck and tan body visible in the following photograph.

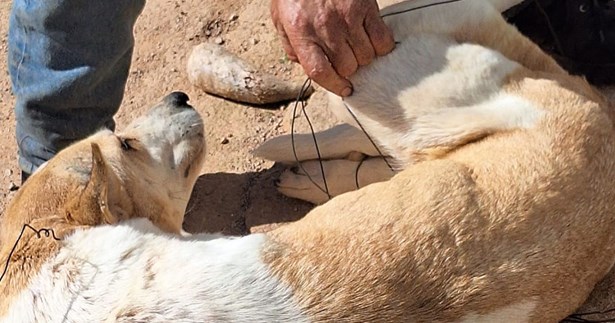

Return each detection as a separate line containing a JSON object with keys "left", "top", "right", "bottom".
{"left": 2, "top": 219, "right": 306, "bottom": 323}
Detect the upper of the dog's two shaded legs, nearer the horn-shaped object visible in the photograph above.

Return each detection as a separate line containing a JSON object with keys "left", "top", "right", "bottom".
{"left": 253, "top": 124, "right": 378, "bottom": 164}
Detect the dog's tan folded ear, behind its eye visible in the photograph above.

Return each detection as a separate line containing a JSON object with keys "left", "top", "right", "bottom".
{"left": 65, "top": 143, "right": 119, "bottom": 226}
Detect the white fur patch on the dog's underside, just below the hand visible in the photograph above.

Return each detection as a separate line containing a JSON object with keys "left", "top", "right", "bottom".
{"left": 332, "top": 34, "right": 539, "bottom": 165}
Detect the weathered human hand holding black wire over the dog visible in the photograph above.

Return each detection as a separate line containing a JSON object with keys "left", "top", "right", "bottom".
{"left": 271, "top": 0, "right": 395, "bottom": 96}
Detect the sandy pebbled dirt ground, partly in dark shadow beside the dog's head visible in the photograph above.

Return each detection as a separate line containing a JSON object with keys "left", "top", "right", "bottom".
{"left": 0, "top": 0, "right": 346, "bottom": 234}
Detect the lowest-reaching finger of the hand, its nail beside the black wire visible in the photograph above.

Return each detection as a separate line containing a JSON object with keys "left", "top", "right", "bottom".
{"left": 297, "top": 43, "right": 352, "bottom": 97}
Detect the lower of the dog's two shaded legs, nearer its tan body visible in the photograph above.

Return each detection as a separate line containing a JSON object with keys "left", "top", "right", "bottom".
{"left": 276, "top": 157, "right": 395, "bottom": 204}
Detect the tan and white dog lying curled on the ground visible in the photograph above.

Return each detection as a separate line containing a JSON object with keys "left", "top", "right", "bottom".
{"left": 0, "top": 0, "right": 615, "bottom": 322}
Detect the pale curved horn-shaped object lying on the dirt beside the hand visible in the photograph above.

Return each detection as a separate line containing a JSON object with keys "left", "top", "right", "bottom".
{"left": 187, "top": 43, "right": 313, "bottom": 105}
